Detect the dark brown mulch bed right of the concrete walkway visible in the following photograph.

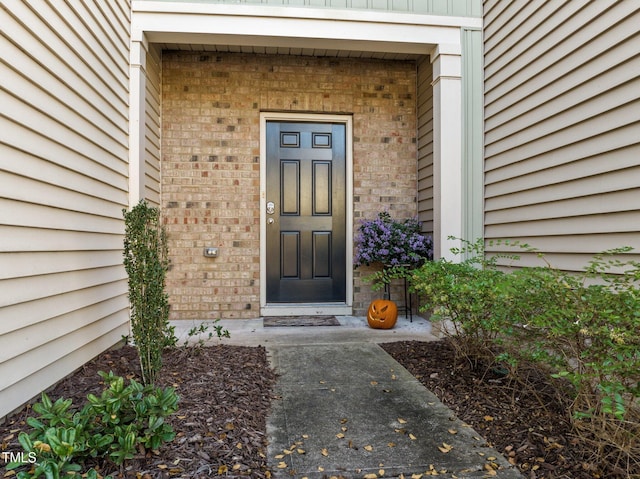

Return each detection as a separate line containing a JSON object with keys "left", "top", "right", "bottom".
{"left": 381, "top": 340, "right": 640, "bottom": 479}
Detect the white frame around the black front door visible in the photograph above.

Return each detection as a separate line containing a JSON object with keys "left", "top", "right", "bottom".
{"left": 260, "top": 112, "right": 353, "bottom": 316}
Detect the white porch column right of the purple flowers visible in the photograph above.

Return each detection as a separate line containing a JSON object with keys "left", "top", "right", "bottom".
{"left": 431, "top": 44, "right": 462, "bottom": 259}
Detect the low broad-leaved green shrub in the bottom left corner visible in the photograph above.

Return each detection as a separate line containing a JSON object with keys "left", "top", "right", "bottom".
{"left": 7, "top": 372, "right": 178, "bottom": 479}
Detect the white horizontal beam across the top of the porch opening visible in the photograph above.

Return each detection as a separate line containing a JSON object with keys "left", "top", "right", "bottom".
{"left": 132, "top": 2, "right": 477, "bottom": 54}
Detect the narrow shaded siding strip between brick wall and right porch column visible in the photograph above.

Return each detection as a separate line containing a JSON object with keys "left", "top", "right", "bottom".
{"left": 417, "top": 57, "right": 433, "bottom": 234}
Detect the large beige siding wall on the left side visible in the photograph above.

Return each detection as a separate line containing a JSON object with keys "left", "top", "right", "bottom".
{"left": 0, "top": 0, "right": 131, "bottom": 417}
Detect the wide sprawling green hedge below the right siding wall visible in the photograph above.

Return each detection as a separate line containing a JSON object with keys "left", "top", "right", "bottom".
{"left": 410, "top": 240, "right": 640, "bottom": 471}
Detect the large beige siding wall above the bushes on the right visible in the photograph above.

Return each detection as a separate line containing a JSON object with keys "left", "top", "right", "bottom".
{"left": 484, "top": 0, "right": 640, "bottom": 269}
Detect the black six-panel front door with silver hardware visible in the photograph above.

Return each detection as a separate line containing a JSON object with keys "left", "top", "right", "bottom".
{"left": 266, "top": 121, "right": 346, "bottom": 303}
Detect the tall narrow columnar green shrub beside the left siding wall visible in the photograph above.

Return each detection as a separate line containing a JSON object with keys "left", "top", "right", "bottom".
{"left": 122, "top": 201, "right": 177, "bottom": 384}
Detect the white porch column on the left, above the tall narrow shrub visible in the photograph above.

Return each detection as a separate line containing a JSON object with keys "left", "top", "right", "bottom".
{"left": 129, "top": 40, "right": 147, "bottom": 208}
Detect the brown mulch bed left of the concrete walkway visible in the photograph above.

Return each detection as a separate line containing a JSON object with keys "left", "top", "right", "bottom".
{"left": 0, "top": 345, "right": 276, "bottom": 479}
